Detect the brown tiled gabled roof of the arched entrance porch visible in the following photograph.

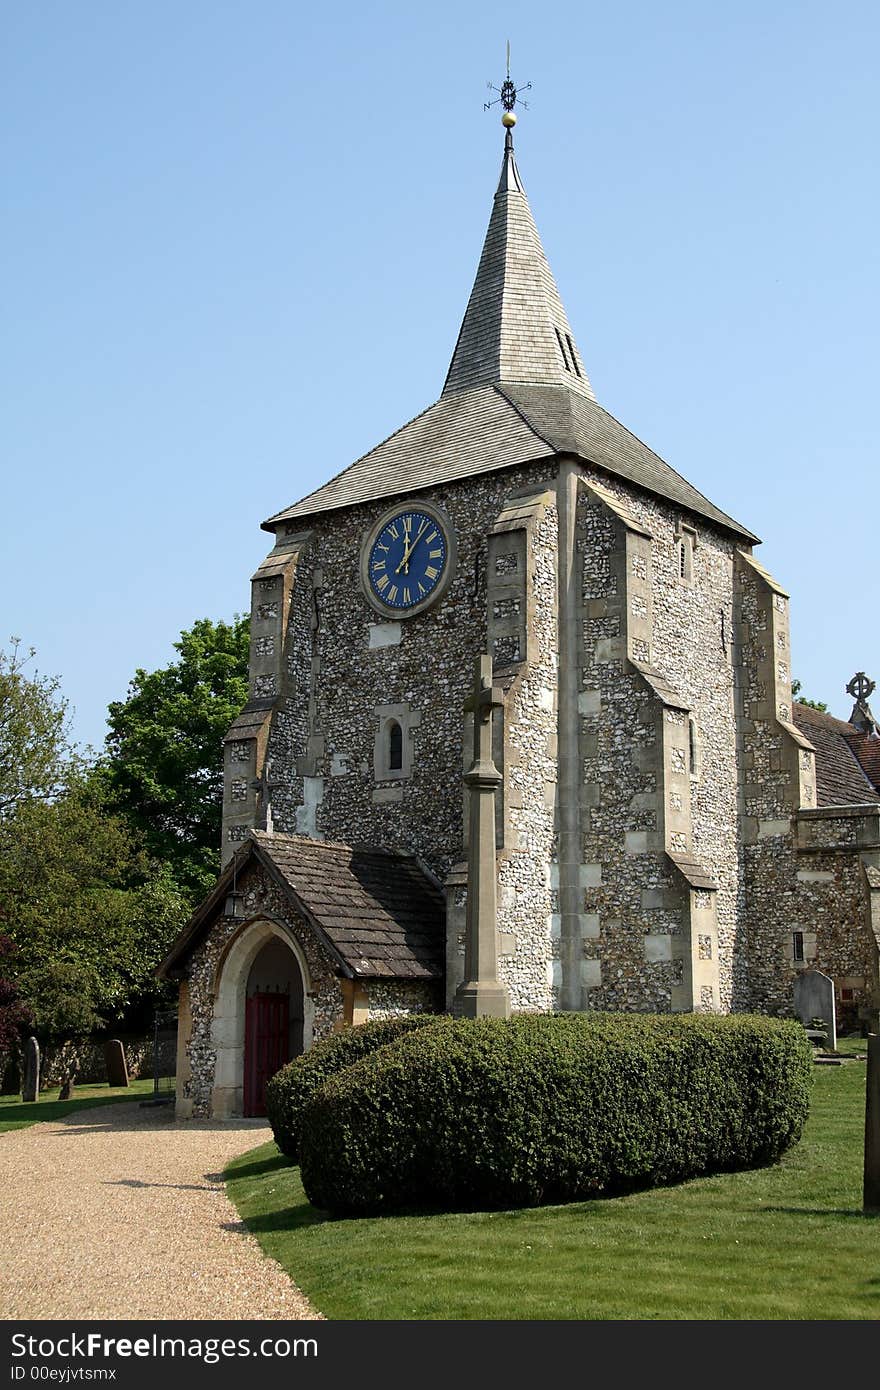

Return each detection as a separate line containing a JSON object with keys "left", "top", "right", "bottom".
{"left": 158, "top": 830, "right": 446, "bottom": 980}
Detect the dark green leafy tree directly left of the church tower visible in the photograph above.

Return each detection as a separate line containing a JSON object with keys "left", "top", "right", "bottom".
{"left": 103, "top": 617, "right": 250, "bottom": 898}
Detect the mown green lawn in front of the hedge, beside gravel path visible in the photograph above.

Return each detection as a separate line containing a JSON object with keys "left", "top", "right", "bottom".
{"left": 227, "top": 1040, "right": 880, "bottom": 1319}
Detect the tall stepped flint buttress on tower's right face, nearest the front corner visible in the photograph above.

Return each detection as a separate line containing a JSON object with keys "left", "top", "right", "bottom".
{"left": 569, "top": 481, "right": 720, "bottom": 1011}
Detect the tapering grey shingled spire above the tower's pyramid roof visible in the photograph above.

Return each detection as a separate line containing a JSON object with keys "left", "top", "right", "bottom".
{"left": 443, "top": 129, "right": 595, "bottom": 400}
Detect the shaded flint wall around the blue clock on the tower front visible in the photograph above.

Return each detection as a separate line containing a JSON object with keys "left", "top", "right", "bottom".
{"left": 257, "top": 468, "right": 556, "bottom": 880}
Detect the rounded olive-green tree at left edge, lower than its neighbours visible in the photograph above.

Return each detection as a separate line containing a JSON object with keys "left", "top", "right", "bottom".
{"left": 0, "top": 771, "right": 188, "bottom": 1041}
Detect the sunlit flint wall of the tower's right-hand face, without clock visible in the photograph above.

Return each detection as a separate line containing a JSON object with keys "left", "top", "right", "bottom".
{"left": 577, "top": 470, "right": 745, "bottom": 1012}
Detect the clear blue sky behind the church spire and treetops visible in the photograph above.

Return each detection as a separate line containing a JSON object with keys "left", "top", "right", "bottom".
{"left": 0, "top": 0, "right": 880, "bottom": 745}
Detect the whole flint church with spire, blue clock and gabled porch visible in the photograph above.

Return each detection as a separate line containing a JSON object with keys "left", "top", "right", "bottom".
{"left": 161, "top": 115, "right": 880, "bottom": 1116}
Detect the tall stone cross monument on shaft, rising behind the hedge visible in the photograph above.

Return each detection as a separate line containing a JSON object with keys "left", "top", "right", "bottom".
{"left": 453, "top": 656, "right": 510, "bottom": 1019}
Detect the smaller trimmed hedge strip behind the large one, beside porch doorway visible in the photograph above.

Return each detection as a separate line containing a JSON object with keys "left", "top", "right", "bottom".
{"left": 266, "top": 1013, "right": 442, "bottom": 1162}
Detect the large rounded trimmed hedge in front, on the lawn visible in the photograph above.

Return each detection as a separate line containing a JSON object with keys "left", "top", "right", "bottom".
{"left": 300, "top": 1013, "right": 813, "bottom": 1213}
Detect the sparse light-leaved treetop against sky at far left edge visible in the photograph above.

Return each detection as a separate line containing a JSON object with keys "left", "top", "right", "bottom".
{"left": 0, "top": 637, "right": 71, "bottom": 817}
